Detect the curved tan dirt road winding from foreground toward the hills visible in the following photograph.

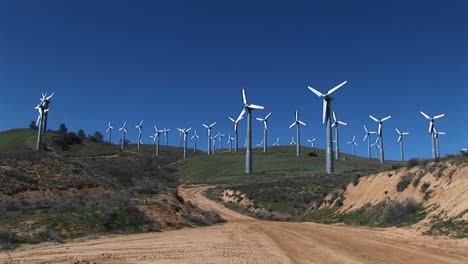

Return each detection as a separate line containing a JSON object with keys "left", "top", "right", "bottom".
{"left": 0, "top": 187, "right": 468, "bottom": 264}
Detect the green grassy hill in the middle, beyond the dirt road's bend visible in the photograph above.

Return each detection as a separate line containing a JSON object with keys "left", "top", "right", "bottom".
{"left": 182, "top": 146, "right": 400, "bottom": 215}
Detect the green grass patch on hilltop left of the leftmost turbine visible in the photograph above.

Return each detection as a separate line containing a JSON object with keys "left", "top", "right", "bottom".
{"left": 0, "top": 128, "right": 37, "bottom": 152}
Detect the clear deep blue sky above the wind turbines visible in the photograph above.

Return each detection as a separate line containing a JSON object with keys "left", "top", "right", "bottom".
{"left": 0, "top": 0, "right": 468, "bottom": 159}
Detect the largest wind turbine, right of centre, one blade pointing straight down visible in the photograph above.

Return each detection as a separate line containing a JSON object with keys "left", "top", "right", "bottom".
{"left": 308, "top": 81, "right": 348, "bottom": 174}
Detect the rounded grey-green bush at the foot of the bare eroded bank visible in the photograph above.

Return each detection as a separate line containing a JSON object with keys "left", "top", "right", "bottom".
{"left": 380, "top": 199, "right": 421, "bottom": 226}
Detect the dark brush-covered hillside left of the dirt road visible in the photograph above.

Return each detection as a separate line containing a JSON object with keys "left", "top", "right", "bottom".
{"left": 0, "top": 129, "right": 221, "bottom": 247}
